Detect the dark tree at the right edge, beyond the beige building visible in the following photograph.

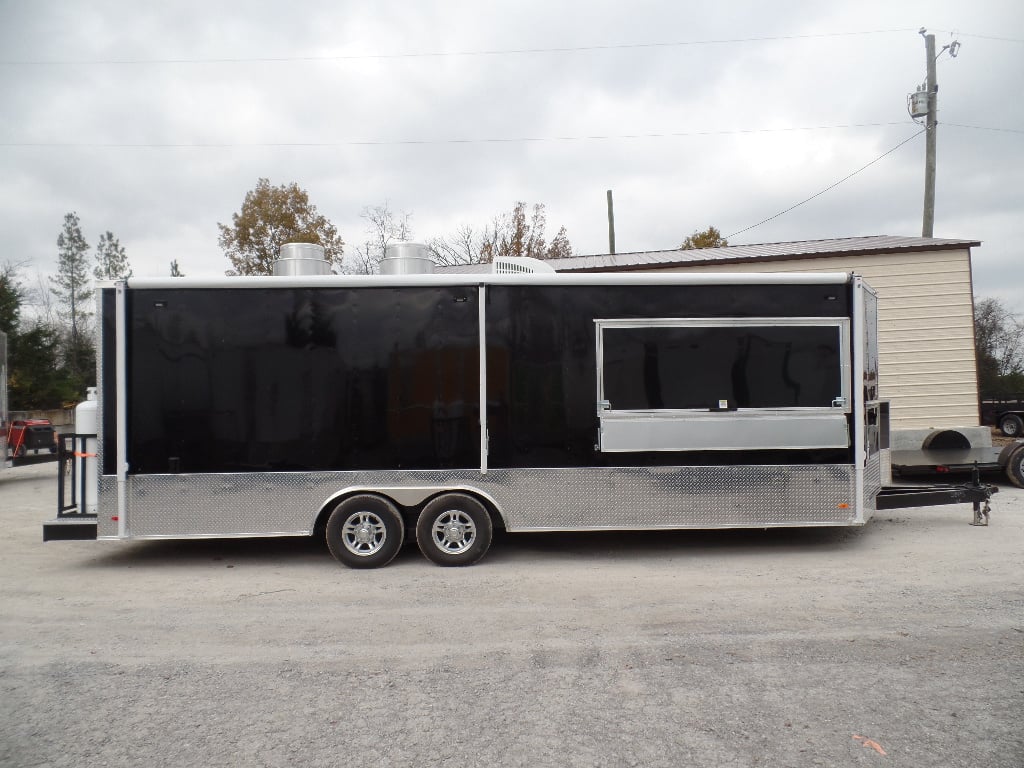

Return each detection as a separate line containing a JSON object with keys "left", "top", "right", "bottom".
{"left": 974, "top": 296, "right": 1024, "bottom": 397}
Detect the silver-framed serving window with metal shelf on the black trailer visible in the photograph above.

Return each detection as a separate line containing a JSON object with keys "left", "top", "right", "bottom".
{"left": 596, "top": 317, "right": 850, "bottom": 451}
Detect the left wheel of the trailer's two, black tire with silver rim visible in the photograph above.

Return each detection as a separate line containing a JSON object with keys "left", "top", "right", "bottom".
{"left": 325, "top": 494, "right": 406, "bottom": 568}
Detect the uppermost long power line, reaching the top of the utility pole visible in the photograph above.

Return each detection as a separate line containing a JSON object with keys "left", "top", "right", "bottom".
{"left": 0, "top": 29, "right": 916, "bottom": 67}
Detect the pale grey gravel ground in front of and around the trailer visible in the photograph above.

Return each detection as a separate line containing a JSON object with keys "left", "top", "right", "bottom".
{"left": 0, "top": 464, "right": 1024, "bottom": 768}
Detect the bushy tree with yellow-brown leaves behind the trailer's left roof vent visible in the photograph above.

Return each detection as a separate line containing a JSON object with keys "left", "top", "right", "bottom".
{"left": 217, "top": 178, "right": 345, "bottom": 274}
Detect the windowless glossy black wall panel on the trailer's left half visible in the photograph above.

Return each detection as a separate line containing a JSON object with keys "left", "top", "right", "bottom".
{"left": 127, "top": 287, "right": 479, "bottom": 474}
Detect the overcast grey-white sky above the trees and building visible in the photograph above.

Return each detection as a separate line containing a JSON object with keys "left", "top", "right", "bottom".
{"left": 0, "top": 0, "right": 1024, "bottom": 310}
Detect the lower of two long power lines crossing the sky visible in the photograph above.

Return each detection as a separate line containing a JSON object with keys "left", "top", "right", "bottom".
{"left": 0, "top": 121, "right": 906, "bottom": 150}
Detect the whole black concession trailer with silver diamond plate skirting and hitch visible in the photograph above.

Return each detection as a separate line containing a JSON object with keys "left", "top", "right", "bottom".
{"left": 44, "top": 252, "right": 988, "bottom": 567}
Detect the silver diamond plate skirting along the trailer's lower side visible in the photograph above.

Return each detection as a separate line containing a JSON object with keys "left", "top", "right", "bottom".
{"left": 98, "top": 465, "right": 856, "bottom": 538}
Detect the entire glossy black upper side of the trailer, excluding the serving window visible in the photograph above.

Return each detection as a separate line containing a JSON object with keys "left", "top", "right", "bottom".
{"left": 108, "top": 285, "right": 850, "bottom": 474}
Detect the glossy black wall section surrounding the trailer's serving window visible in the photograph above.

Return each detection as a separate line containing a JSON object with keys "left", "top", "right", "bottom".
{"left": 486, "top": 285, "right": 851, "bottom": 469}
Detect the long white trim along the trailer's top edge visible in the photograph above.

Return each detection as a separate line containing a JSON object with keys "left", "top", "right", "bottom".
{"left": 121, "top": 272, "right": 851, "bottom": 290}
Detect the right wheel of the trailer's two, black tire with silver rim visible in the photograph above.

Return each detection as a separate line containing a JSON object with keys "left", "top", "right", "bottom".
{"left": 416, "top": 494, "right": 494, "bottom": 565}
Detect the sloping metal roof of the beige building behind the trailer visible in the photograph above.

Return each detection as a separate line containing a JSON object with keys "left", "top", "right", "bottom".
{"left": 439, "top": 234, "right": 981, "bottom": 272}
